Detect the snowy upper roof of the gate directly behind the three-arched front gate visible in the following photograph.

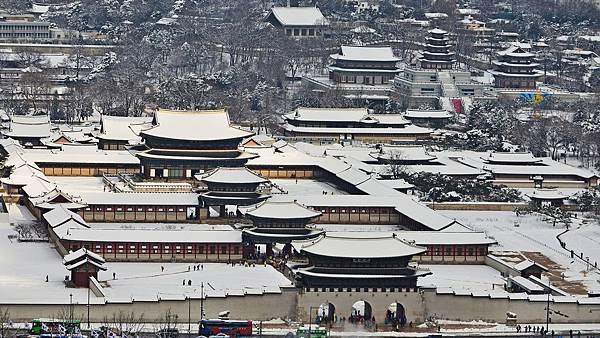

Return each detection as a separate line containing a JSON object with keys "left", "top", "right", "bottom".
{"left": 246, "top": 200, "right": 321, "bottom": 219}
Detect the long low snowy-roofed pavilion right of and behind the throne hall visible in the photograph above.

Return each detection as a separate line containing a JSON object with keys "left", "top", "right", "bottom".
{"left": 282, "top": 107, "right": 432, "bottom": 144}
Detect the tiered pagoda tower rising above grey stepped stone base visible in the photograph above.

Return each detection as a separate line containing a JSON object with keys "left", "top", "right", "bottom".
{"left": 419, "top": 28, "right": 456, "bottom": 69}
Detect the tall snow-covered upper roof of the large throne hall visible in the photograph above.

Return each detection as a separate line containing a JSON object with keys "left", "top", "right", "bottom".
{"left": 140, "top": 110, "right": 253, "bottom": 141}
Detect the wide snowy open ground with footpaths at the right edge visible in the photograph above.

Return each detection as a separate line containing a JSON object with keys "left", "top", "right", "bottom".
{"left": 439, "top": 210, "right": 600, "bottom": 290}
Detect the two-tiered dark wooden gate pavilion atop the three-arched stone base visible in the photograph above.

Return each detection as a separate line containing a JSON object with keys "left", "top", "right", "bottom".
{"left": 292, "top": 234, "right": 430, "bottom": 292}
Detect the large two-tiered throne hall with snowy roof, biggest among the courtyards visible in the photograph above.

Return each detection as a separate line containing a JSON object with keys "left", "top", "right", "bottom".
{"left": 136, "top": 110, "right": 256, "bottom": 180}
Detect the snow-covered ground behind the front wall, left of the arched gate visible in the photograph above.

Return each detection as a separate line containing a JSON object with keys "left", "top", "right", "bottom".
{"left": 0, "top": 205, "right": 291, "bottom": 304}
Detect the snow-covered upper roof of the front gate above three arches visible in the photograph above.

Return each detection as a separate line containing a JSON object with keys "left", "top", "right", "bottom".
{"left": 292, "top": 235, "right": 427, "bottom": 258}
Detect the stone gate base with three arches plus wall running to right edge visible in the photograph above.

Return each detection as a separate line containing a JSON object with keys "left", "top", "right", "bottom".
{"left": 297, "top": 289, "right": 600, "bottom": 323}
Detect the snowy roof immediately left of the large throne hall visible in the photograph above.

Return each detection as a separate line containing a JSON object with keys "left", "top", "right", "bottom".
{"left": 97, "top": 115, "right": 152, "bottom": 144}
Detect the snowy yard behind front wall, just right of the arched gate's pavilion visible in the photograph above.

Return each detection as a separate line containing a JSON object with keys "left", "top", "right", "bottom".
{"left": 419, "top": 264, "right": 505, "bottom": 291}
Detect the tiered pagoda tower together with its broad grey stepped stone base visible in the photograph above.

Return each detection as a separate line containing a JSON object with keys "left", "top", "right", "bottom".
{"left": 394, "top": 28, "right": 488, "bottom": 109}
